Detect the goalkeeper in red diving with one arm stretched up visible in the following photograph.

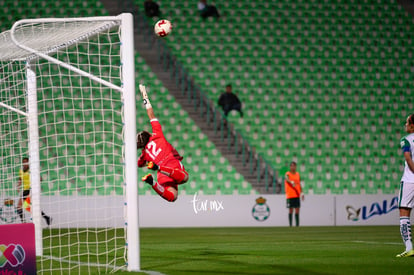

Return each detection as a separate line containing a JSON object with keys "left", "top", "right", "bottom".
{"left": 137, "top": 84, "right": 188, "bottom": 202}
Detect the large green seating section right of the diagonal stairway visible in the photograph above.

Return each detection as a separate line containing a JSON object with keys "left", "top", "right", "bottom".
{"left": 135, "top": 0, "right": 414, "bottom": 194}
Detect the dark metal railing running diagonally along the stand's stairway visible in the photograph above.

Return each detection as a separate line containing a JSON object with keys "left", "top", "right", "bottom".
{"left": 134, "top": 10, "right": 281, "bottom": 193}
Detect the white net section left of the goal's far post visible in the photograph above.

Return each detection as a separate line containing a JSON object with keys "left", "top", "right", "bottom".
{"left": 0, "top": 62, "right": 28, "bottom": 224}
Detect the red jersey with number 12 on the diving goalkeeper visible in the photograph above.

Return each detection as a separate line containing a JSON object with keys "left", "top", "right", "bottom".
{"left": 138, "top": 118, "right": 183, "bottom": 167}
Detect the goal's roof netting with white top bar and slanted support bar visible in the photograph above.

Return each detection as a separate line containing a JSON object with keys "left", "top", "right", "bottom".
{"left": 0, "top": 17, "right": 122, "bottom": 91}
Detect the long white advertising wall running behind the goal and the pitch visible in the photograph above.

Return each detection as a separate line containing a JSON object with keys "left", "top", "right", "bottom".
{"left": 7, "top": 194, "right": 398, "bottom": 227}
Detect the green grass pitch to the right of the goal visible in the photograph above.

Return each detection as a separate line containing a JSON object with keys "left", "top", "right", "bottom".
{"left": 38, "top": 226, "right": 414, "bottom": 274}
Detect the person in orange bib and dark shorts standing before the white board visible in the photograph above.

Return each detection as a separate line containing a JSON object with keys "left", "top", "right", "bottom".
{"left": 285, "top": 161, "right": 305, "bottom": 226}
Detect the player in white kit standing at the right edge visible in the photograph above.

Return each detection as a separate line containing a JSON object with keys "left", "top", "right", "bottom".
{"left": 397, "top": 114, "right": 414, "bottom": 257}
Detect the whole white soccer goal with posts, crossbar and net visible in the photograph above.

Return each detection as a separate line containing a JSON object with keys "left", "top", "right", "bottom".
{"left": 0, "top": 14, "right": 139, "bottom": 274}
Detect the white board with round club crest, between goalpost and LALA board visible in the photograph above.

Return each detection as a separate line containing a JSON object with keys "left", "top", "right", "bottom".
{"left": 140, "top": 194, "right": 334, "bottom": 227}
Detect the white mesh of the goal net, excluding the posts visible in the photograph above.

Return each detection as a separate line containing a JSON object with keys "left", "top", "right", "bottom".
{"left": 0, "top": 18, "right": 125, "bottom": 274}
